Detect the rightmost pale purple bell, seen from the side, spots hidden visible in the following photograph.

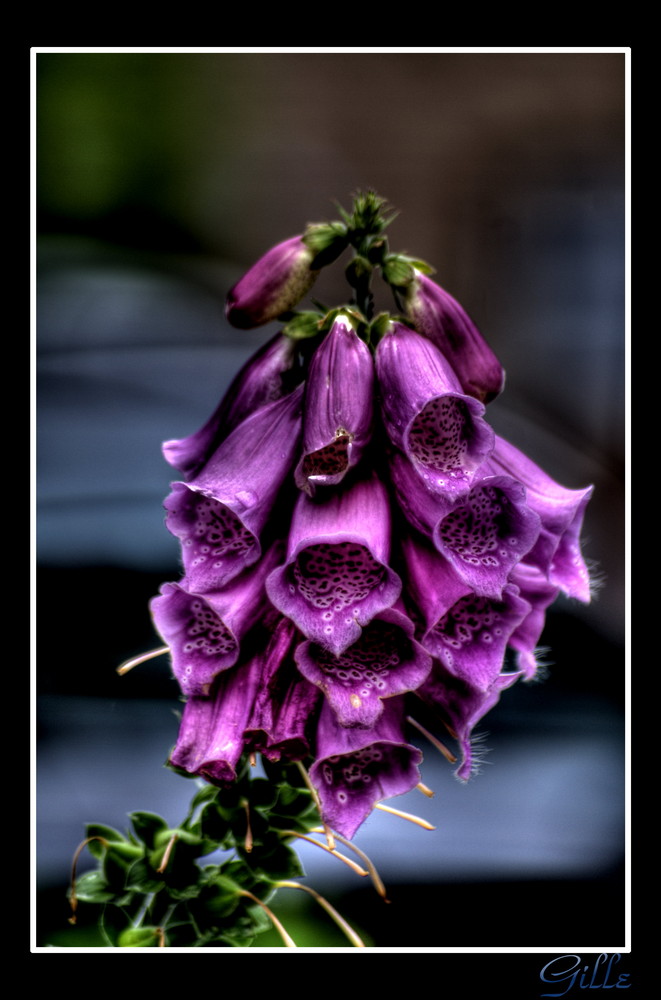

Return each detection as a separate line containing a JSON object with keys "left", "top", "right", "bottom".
{"left": 485, "top": 437, "right": 593, "bottom": 604}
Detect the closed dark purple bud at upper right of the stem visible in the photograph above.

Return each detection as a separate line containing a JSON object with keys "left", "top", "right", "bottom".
{"left": 406, "top": 270, "right": 505, "bottom": 403}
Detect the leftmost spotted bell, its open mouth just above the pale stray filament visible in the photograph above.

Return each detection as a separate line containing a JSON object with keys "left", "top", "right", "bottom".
{"left": 150, "top": 544, "right": 282, "bottom": 695}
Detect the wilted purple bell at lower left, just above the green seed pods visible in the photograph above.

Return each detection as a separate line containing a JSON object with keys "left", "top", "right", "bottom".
{"left": 169, "top": 657, "right": 261, "bottom": 785}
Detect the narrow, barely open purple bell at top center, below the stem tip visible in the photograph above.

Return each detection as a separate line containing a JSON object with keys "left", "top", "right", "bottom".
{"left": 295, "top": 315, "right": 374, "bottom": 496}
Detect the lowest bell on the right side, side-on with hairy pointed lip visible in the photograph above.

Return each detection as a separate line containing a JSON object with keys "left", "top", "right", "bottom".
{"left": 416, "top": 661, "right": 521, "bottom": 781}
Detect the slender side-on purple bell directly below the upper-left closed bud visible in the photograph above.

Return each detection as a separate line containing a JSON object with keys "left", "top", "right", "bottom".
{"left": 163, "top": 333, "right": 297, "bottom": 479}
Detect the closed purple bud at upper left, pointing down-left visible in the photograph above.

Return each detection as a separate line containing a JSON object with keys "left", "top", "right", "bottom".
{"left": 225, "top": 236, "right": 319, "bottom": 330}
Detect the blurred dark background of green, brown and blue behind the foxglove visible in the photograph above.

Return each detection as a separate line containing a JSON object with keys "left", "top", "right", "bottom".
{"left": 35, "top": 51, "right": 626, "bottom": 948}
